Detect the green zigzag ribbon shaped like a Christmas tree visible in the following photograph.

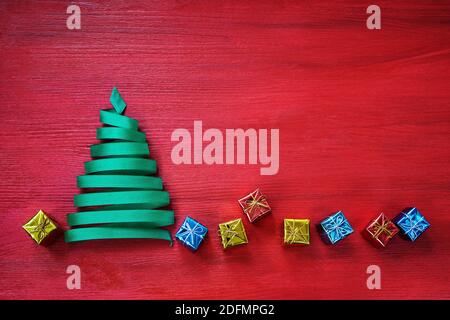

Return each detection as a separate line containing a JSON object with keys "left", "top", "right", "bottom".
{"left": 65, "top": 88, "right": 174, "bottom": 243}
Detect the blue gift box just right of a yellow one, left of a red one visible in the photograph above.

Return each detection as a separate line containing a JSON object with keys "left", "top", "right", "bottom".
{"left": 320, "top": 211, "right": 353, "bottom": 244}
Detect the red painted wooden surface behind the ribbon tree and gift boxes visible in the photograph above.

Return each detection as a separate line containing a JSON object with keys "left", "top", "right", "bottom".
{"left": 0, "top": 0, "right": 450, "bottom": 299}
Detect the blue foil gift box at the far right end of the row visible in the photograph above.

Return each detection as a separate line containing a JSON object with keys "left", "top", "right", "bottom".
{"left": 392, "top": 208, "right": 430, "bottom": 241}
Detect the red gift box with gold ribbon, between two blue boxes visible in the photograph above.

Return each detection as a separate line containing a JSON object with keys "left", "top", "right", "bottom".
{"left": 363, "top": 213, "right": 399, "bottom": 247}
